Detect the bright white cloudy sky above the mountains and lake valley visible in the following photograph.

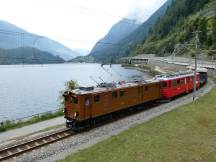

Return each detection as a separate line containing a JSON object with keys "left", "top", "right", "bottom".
{"left": 0, "top": 0, "right": 166, "bottom": 50}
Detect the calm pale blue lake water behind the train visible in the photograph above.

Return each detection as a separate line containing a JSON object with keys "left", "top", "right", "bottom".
{"left": 0, "top": 64, "right": 149, "bottom": 121}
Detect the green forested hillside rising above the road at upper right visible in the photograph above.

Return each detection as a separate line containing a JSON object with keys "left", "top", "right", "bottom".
{"left": 133, "top": 0, "right": 216, "bottom": 56}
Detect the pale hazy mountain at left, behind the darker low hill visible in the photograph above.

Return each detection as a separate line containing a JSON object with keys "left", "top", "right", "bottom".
{"left": 0, "top": 21, "right": 79, "bottom": 60}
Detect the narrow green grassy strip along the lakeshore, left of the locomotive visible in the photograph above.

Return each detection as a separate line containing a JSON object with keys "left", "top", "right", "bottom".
{"left": 0, "top": 109, "right": 64, "bottom": 132}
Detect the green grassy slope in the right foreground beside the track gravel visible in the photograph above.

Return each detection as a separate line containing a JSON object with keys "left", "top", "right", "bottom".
{"left": 60, "top": 82, "right": 216, "bottom": 162}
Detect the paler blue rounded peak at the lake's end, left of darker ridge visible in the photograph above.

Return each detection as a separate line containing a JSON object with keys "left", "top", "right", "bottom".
{"left": 89, "top": 19, "right": 140, "bottom": 61}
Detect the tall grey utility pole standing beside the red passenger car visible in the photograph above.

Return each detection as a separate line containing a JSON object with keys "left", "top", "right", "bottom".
{"left": 193, "top": 31, "right": 201, "bottom": 101}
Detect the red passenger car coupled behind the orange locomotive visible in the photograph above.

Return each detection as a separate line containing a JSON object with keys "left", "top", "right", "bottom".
{"left": 158, "top": 72, "right": 200, "bottom": 99}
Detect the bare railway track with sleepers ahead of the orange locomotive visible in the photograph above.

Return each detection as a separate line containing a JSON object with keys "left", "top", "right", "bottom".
{"left": 0, "top": 129, "right": 75, "bottom": 162}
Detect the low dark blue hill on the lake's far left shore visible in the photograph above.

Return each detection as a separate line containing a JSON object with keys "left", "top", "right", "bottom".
{"left": 0, "top": 47, "right": 64, "bottom": 65}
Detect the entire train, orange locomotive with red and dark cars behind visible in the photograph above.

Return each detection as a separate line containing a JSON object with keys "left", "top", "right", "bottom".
{"left": 63, "top": 71, "right": 207, "bottom": 130}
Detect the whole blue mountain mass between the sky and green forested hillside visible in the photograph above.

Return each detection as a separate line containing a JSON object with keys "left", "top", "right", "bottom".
{"left": 90, "top": 0, "right": 172, "bottom": 62}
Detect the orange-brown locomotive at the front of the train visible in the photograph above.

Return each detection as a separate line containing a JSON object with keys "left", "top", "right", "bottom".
{"left": 63, "top": 80, "right": 161, "bottom": 128}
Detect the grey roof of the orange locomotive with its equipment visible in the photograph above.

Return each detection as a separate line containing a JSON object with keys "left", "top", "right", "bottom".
{"left": 71, "top": 78, "right": 159, "bottom": 95}
